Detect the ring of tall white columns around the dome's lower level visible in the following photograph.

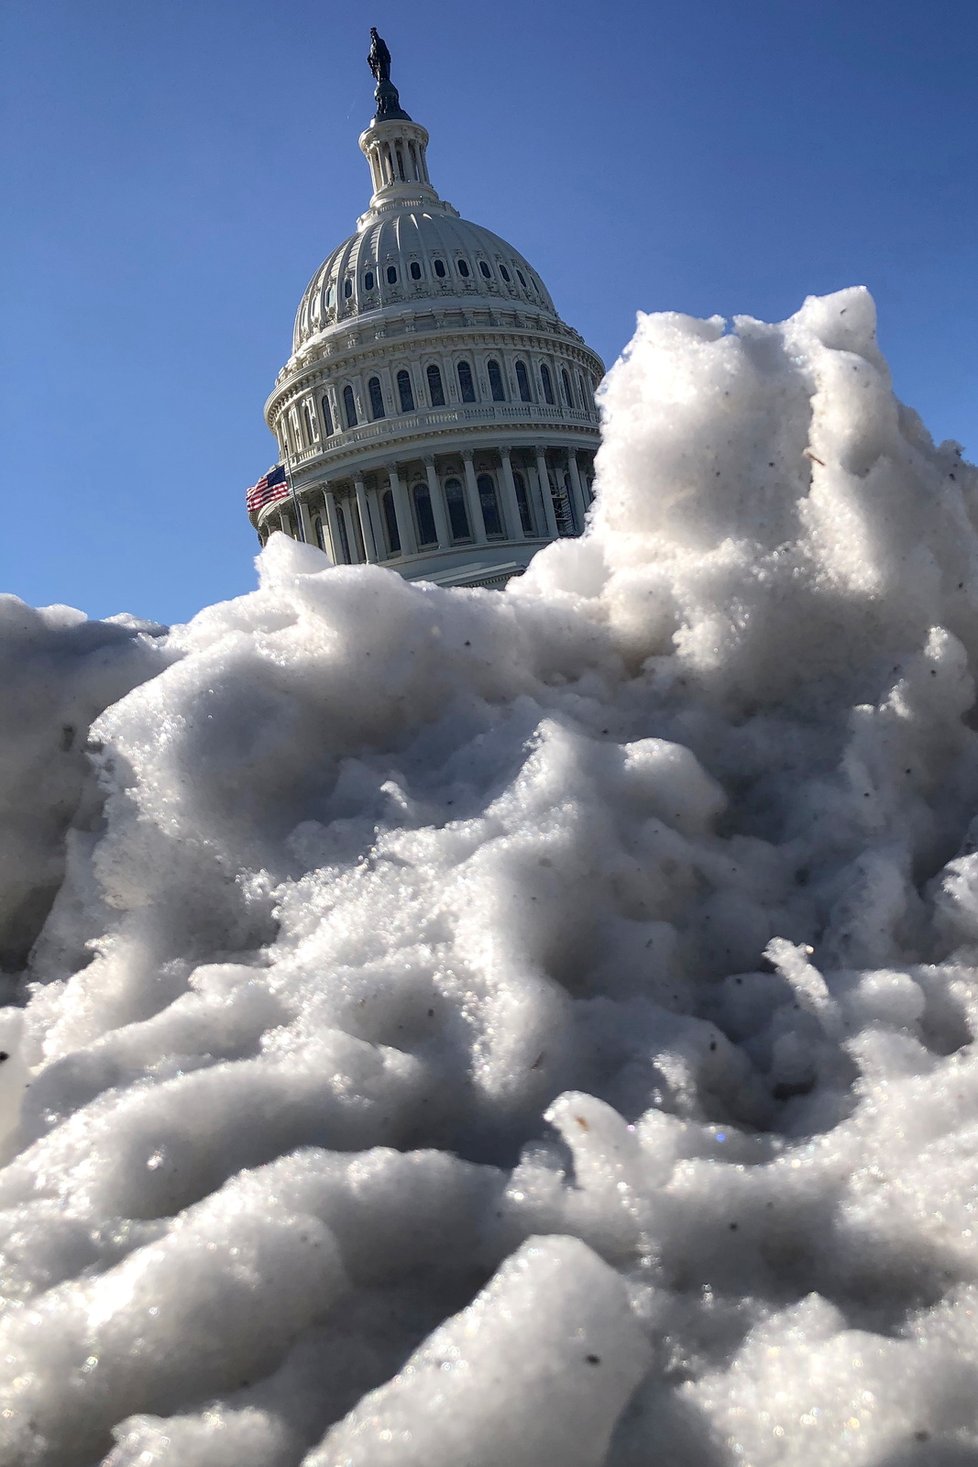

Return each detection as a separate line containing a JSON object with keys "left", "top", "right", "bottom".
{"left": 265, "top": 445, "right": 592, "bottom": 565}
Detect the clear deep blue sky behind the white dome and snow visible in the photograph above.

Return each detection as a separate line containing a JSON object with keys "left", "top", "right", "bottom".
{"left": 0, "top": 0, "right": 978, "bottom": 621}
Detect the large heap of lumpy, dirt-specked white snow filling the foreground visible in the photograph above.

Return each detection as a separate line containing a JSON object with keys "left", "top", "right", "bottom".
{"left": 0, "top": 290, "right": 978, "bottom": 1467}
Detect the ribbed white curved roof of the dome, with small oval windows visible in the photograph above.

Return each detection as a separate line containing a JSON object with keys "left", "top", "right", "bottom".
{"left": 293, "top": 206, "right": 557, "bottom": 352}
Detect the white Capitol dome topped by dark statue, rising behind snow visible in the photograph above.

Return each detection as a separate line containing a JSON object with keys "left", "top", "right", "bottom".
{"left": 249, "top": 31, "right": 604, "bottom": 585}
